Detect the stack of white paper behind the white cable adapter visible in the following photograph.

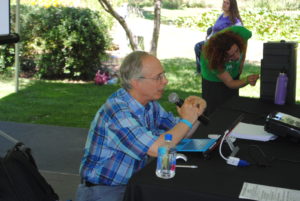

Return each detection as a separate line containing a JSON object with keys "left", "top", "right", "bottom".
{"left": 230, "top": 122, "right": 277, "bottom": 141}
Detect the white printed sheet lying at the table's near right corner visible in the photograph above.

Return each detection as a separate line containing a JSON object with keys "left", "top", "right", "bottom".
{"left": 239, "top": 182, "right": 300, "bottom": 201}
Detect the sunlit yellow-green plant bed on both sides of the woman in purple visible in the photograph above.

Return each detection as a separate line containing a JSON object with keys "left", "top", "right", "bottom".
{"left": 167, "top": 9, "right": 300, "bottom": 42}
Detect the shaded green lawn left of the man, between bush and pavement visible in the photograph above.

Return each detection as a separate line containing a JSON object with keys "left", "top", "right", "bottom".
{"left": 0, "top": 81, "right": 118, "bottom": 127}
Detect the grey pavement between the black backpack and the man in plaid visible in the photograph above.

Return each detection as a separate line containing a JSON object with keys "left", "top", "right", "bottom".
{"left": 0, "top": 121, "right": 88, "bottom": 201}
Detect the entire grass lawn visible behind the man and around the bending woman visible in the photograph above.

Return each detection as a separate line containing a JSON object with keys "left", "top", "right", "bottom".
{"left": 0, "top": 58, "right": 276, "bottom": 128}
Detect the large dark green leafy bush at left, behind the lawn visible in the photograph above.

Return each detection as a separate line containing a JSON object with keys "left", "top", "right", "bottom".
{"left": 3, "top": 6, "right": 111, "bottom": 80}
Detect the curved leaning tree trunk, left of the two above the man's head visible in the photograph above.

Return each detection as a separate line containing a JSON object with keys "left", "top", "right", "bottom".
{"left": 98, "top": 0, "right": 137, "bottom": 51}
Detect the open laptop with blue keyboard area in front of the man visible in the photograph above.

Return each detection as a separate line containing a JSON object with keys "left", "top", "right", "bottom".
{"left": 176, "top": 114, "right": 244, "bottom": 157}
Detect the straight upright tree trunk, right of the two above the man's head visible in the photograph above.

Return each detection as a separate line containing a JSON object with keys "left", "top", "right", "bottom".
{"left": 150, "top": 0, "right": 162, "bottom": 56}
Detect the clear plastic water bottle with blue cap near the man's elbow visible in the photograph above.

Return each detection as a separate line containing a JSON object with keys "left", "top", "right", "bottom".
{"left": 156, "top": 134, "right": 176, "bottom": 179}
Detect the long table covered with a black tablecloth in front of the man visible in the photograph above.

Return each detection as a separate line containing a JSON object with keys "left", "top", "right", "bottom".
{"left": 124, "top": 97, "right": 300, "bottom": 201}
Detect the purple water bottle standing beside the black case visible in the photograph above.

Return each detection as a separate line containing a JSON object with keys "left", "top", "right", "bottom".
{"left": 274, "top": 72, "right": 288, "bottom": 105}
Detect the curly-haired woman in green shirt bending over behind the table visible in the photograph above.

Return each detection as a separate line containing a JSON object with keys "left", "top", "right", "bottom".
{"left": 200, "top": 26, "right": 259, "bottom": 115}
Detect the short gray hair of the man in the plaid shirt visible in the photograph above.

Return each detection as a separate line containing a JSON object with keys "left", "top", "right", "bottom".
{"left": 120, "top": 51, "right": 151, "bottom": 90}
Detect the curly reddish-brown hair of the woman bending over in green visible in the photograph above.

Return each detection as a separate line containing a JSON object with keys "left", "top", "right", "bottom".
{"left": 203, "top": 31, "right": 246, "bottom": 72}
